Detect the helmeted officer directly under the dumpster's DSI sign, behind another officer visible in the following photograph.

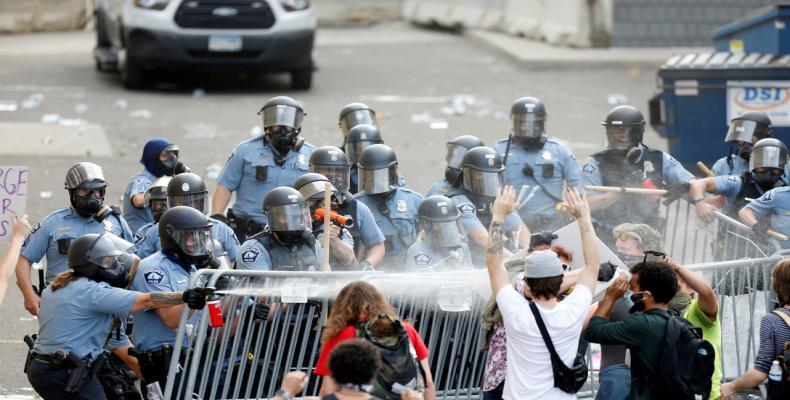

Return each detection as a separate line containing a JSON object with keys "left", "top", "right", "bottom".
{"left": 711, "top": 111, "right": 773, "bottom": 176}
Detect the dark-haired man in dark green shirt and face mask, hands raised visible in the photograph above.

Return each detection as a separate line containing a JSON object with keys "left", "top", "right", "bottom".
{"left": 584, "top": 261, "right": 678, "bottom": 400}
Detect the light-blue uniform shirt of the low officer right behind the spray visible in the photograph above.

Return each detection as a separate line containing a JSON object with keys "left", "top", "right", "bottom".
{"left": 406, "top": 237, "right": 473, "bottom": 271}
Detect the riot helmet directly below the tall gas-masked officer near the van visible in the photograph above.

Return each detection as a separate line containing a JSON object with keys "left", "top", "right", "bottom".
{"left": 263, "top": 186, "right": 313, "bottom": 244}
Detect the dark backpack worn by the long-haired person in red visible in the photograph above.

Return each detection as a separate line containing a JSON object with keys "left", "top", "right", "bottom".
{"left": 356, "top": 314, "right": 425, "bottom": 400}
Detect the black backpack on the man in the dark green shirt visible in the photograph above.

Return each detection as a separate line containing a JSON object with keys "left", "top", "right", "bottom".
{"left": 647, "top": 310, "right": 716, "bottom": 400}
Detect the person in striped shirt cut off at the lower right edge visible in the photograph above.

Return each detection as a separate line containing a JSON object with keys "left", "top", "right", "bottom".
{"left": 721, "top": 258, "right": 790, "bottom": 400}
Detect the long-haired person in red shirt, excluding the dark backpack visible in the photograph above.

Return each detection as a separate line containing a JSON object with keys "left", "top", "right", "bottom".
{"left": 315, "top": 281, "right": 436, "bottom": 400}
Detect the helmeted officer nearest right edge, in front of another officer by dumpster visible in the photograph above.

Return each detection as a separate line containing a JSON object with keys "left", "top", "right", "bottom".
{"left": 689, "top": 138, "right": 788, "bottom": 221}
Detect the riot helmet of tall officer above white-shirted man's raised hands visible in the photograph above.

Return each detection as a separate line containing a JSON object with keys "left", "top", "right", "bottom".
{"left": 510, "top": 97, "right": 546, "bottom": 148}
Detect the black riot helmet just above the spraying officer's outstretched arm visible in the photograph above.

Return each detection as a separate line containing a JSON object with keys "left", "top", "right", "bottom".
{"left": 159, "top": 206, "right": 213, "bottom": 269}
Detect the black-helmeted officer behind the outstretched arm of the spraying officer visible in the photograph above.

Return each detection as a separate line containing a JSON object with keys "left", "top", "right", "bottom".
{"left": 131, "top": 206, "right": 214, "bottom": 390}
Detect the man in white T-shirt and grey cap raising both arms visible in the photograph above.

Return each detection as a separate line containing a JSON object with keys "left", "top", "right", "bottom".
{"left": 486, "top": 186, "right": 600, "bottom": 400}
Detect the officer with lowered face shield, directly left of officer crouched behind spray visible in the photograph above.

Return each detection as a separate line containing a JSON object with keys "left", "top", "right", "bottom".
{"left": 354, "top": 144, "right": 422, "bottom": 271}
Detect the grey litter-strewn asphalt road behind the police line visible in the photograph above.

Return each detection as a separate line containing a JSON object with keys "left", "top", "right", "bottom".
{"left": 0, "top": 24, "right": 665, "bottom": 396}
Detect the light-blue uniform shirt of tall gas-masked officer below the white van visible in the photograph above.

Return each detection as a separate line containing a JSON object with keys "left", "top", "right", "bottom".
{"left": 217, "top": 137, "right": 315, "bottom": 225}
